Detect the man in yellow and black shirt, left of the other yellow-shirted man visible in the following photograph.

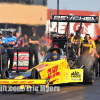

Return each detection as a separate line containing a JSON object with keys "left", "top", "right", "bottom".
{"left": 71, "top": 30, "right": 84, "bottom": 55}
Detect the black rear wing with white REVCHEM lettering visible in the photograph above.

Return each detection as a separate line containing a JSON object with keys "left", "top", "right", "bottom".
{"left": 50, "top": 15, "right": 99, "bottom": 23}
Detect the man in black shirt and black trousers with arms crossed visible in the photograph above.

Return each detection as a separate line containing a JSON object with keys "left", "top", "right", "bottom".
{"left": 29, "top": 31, "right": 39, "bottom": 69}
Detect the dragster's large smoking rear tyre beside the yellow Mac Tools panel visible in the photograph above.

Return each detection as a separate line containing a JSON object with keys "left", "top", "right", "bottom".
{"left": 78, "top": 57, "right": 95, "bottom": 84}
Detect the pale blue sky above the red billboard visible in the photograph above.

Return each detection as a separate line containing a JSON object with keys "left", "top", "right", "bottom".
{"left": 47, "top": 0, "right": 100, "bottom": 11}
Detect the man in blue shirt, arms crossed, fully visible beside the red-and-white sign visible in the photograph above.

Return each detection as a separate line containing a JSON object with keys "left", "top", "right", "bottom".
{"left": 6, "top": 30, "right": 17, "bottom": 72}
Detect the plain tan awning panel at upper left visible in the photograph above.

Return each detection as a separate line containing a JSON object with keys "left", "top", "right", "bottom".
{"left": 0, "top": 3, "right": 47, "bottom": 25}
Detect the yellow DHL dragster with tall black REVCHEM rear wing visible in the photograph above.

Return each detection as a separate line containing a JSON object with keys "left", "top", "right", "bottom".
{"left": 1, "top": 15, "right": 97, "bottom": 93}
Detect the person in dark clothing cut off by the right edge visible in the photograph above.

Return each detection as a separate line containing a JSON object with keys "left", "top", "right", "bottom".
{"left": 95, "top": 35, "right": 100, "bottom": 76}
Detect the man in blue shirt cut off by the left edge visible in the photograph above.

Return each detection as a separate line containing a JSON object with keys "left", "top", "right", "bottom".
{"left": 0, "top": 31, "right": 9, "bottom": 74}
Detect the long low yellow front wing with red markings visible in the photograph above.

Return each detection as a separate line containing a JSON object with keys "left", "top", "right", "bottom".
{"left": 0, "top": 79, "right": 47, "bottom": 85}
